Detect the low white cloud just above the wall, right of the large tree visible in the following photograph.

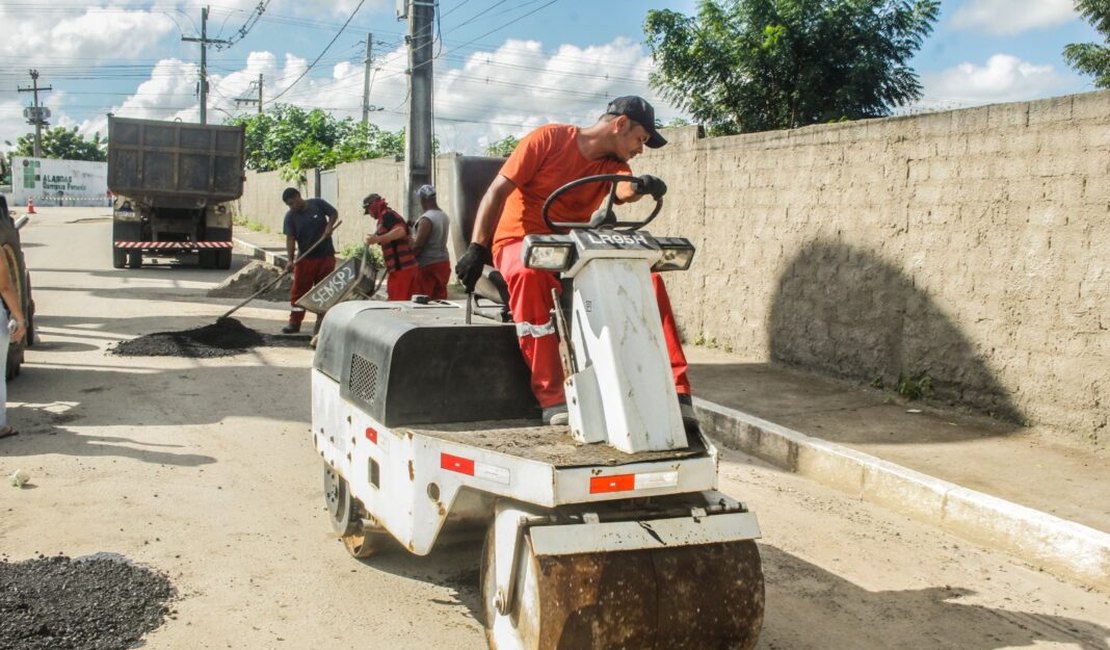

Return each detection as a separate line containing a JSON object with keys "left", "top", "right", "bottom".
{"left": 920, "top": 54, "right": 1068, "bottom": 108}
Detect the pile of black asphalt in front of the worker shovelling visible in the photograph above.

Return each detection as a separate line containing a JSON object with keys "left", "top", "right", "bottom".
{"left": 109, "top": 318, "right": 306, "bottom": 358}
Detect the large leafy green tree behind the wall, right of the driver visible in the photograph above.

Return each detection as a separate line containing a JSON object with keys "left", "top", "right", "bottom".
{"left": 644, "top": 0, "right": 940, "bottom": 134}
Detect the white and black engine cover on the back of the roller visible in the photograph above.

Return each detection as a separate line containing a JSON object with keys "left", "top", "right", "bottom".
{"left": 313, "top": 301, "right": 539, "bottom": 427}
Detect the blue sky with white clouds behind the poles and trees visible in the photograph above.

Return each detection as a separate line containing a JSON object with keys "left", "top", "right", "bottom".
{"left": 0, "top": 0, "right": 1102, "bottom": 153}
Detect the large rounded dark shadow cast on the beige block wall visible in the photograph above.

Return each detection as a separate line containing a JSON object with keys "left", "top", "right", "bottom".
{"left": 770, "top": 241, "right": 1025, "bottom": 423}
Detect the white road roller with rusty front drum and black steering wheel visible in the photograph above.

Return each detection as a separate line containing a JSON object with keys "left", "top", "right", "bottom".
{"left": 312, "top": 174, "right": 764, "bottom": 650}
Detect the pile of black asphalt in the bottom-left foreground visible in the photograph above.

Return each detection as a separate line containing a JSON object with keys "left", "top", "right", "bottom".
{"left": 0, "top": 553, "right": 176, "bottom": 650}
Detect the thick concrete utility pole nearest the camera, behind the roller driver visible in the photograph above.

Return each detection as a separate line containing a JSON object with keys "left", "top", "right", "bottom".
{"left": 405, "top": 0, "right": 435, "bottom": 219}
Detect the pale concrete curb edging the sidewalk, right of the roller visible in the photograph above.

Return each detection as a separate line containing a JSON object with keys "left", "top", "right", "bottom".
{"left": 694, "top": 398, "right": 1110, "bottom": 592}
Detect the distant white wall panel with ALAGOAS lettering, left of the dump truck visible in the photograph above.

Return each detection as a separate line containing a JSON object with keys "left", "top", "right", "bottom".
{"left": 11, "top": 158, "right": 109, "bottom": 206}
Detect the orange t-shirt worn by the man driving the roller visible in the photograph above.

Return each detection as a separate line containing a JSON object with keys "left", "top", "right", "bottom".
{"left": 493, "top": 124, "right": 632, "bottom": 256}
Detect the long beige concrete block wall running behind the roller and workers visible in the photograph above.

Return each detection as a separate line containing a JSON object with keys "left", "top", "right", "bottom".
{"left": 234, "top": 91, "right": 1110, "bottom": 446}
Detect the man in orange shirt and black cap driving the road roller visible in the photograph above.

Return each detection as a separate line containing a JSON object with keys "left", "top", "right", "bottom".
{"left": 455, "top": 97, "right": 696, "bottom": 425}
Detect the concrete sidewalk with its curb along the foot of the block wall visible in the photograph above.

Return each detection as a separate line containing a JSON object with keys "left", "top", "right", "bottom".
{"left": 229, "top": 228, "right": 1110, "bottom": 591}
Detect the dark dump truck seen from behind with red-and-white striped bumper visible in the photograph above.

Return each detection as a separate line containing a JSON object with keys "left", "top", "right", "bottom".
{"left": 108, "top": 116, "right": 245, "bottom": 268}
